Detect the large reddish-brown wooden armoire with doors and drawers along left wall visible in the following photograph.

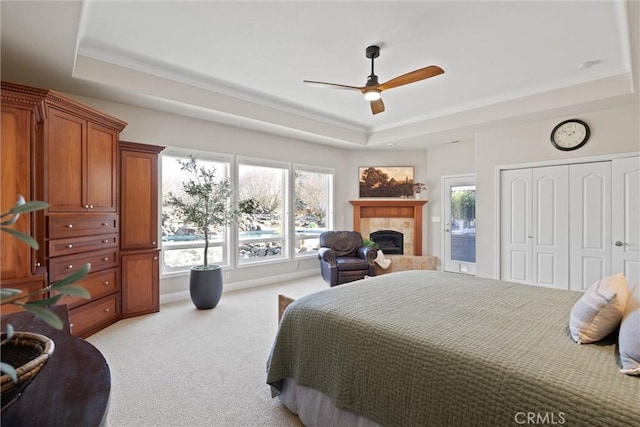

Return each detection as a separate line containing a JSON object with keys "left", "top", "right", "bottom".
{"left": 0, "top": 82, "right": 159, "bottom": 337}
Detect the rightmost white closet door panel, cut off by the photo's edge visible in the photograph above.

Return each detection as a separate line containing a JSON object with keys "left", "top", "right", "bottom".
{"left": 611, "top": 157, "right": 640, "bottom": 287}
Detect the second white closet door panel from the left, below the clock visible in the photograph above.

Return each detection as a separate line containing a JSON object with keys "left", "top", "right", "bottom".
{"left": 531, "top": 166, "right": 569, "bottom": 289}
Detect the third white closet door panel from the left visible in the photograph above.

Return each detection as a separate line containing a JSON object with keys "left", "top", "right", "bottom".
{"left": 569, "top": 162, "right": 611, "bottom": 290}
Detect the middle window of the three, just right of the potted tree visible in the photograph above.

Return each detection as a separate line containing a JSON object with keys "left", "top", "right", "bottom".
{"left": 238, "top": 158, "right": 289, "bottom": 265}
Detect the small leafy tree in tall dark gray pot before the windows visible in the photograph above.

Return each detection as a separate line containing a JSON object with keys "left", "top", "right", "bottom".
{"left": 166, "top": 155, "right": 238, "bottom": 310}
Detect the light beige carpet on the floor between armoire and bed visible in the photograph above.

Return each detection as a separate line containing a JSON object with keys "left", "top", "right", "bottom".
{"left": 87, "top": 276, "right": 329, "bottom": 427}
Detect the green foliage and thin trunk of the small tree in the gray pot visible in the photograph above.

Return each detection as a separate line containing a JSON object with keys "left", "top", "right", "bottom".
{"left": 166, "top": 155, "right": 240, "bottom": 267}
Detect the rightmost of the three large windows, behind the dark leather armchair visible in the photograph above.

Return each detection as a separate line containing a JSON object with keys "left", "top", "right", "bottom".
{"left": 293, "top": 165, "right": 333, "bottom": 258}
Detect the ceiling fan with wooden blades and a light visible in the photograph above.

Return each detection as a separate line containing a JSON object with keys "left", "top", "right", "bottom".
{"left": 303, "top": 46, "right": 444, "bottom": 114}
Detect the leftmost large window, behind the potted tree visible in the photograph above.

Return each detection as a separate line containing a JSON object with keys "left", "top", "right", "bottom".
{"left": 162, "top": 153, "right": 231, "bottom": 274}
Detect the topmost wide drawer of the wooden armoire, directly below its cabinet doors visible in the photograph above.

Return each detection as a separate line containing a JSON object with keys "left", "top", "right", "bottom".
{"left": 48, "top": 214, "right": 119, "bottom": 239}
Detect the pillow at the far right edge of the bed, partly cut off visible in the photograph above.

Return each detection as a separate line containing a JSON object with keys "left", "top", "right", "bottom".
{"left": 618, "top": 284, "right": 640, "bottom": 375}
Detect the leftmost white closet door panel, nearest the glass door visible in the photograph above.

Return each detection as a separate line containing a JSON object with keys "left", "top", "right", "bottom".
{"left": 500, "top": 169, "right": 532, "bottom": 284}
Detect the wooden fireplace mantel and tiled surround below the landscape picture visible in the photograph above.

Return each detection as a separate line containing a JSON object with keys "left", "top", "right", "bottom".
{"left": 349, "top": 199, "right": 427, "bottom": 255}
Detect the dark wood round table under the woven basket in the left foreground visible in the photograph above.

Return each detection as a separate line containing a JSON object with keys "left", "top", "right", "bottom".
{"left": 0, "top": 306, "right": 111, "bottom": 427}
